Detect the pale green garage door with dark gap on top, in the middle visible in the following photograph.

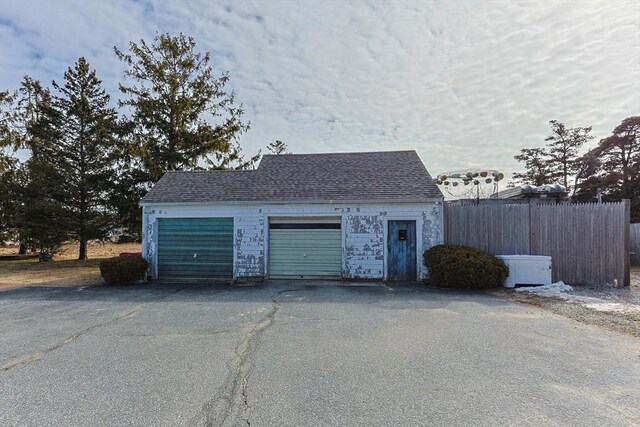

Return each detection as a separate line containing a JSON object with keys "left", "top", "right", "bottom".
{"left": 268, "top": 217, "right": 342, "bottom": 279}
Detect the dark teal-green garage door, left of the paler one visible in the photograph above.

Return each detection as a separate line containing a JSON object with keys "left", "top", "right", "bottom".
{"left": 158, "top": 218, "right": 233, "bottom": 279}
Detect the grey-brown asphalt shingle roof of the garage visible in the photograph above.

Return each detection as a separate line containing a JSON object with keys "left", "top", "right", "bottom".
{"left": 142, "top": 151, "right": 442, "bottom": 203}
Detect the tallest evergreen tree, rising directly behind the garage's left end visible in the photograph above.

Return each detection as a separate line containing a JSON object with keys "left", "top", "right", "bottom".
{"left": 114, "top": 34, "right": 258, "bottom": 184}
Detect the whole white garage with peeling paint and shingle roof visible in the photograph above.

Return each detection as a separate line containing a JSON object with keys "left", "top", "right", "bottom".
{"left": 140, "top": 151, "right": 443, "bottom": 280}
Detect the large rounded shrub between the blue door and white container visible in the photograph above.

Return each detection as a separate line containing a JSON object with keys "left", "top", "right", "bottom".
{"left": 424, "top": 245, "right": 509, "bottom": 289}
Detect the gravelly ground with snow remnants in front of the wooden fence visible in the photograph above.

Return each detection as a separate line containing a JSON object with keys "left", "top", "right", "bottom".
{"left": 492, "top": 267, "right": 640, "bottom": 337}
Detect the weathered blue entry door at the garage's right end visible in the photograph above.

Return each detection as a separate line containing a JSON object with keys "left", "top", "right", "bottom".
{"left": 387, "top": 220, "right": 417, "bottom": 281}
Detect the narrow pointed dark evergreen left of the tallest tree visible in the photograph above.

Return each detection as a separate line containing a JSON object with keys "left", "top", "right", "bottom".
{"left": 36, "top": 58, "right": 116, "bottom": 259}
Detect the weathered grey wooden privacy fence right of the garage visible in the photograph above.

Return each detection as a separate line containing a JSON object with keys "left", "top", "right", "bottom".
{"left": 444, "top": 200, "right": 631, "bottom": 286}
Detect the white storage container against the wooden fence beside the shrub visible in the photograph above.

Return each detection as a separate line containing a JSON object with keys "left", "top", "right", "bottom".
{"left": 496, "top": 255, "right": 551, "bottom": 288}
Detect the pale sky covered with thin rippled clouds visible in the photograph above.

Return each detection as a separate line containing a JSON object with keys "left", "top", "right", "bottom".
{"left": 0, "top": 0, "right": 640, "bottom": 175}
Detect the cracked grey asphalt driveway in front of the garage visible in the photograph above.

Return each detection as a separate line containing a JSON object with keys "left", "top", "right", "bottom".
{"left": 0, "top": 282, "right": 640, "bottom": 426}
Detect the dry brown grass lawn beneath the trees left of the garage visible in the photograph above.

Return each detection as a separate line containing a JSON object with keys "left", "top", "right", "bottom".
{"left": 0, "top": 243, "right": 140, "bottom": 289}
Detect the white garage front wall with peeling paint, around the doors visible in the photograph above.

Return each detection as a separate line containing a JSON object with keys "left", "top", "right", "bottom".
{"left": 142, "top": 202, "right": 443, "bottom": 279}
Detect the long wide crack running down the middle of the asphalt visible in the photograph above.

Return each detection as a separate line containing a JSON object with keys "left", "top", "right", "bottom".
{"left": 194, "top": 289, "right": 304, "bottom": 427}
